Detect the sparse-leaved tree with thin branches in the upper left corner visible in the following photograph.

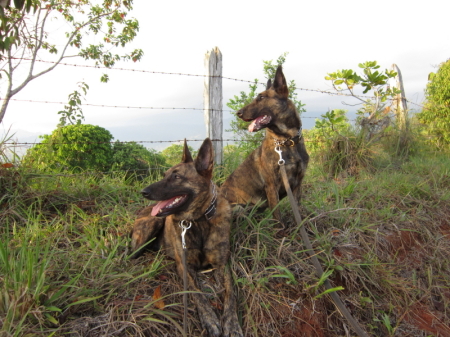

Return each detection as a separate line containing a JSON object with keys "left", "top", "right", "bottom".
{"left": 0, "top": 0, "right": 143, "bottom": 122}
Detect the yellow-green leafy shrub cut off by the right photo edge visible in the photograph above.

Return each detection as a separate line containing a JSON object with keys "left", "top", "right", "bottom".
{"left": 418, "top": 59, "right": 450, "bottom": 147}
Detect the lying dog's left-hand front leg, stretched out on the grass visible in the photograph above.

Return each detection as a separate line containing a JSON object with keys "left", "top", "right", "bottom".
{"left": 178, "top": 263, "right": 222, "bottom": 337}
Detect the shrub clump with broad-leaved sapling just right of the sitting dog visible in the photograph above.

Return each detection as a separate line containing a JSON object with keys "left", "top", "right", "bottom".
{"left": 305, "top": 61, "right": 415, "bottom": 177}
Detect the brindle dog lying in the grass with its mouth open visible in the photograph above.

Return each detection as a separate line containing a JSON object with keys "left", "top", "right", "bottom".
{"left": 132, "top": 138, "right": 243, "bottom": 337}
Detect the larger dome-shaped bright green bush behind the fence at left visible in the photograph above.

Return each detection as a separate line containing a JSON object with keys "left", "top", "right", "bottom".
{"left": 23, "top": 124, "right": 113, "bottom": 172}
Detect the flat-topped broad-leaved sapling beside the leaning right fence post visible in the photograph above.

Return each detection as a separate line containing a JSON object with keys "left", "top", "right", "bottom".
{"left": 325, "top": 61, "right": 399, "bottom": 139}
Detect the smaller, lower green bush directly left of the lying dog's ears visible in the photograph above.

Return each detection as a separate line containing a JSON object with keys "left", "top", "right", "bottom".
{"left": 111, "top": 141, "right": 167, "bottom": 177}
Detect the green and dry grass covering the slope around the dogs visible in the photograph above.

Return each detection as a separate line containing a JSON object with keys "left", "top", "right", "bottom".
{"left": 0, "top": 144, "right": 450, "bottom": 336}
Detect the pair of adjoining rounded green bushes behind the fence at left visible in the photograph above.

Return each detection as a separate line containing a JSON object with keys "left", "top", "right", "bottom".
{"left": 23, "top": 124, "right": 166, "bottom": 178}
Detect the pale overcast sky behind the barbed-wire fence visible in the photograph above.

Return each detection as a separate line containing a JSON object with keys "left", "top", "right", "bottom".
{"left": 0, "top": 0, "right": 450, "bottom": 150}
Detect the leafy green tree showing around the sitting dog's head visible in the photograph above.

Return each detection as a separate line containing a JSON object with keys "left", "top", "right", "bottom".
{"left": 227, "top": 53, "right": 306, "bottom": 154}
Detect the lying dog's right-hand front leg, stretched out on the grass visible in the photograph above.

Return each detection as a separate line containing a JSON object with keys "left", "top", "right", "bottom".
{"left": 215, "top": 265, "right": 244, "bottom": 337}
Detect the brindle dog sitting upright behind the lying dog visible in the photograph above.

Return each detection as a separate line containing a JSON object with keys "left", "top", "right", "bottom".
{"left": 221, "top": 66, "right": 309, "bottom": 222}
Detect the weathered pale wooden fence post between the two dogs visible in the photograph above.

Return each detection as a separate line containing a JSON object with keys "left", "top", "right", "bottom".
{"left": 203, "top": 47, "right": 223, "bottom": 165}
